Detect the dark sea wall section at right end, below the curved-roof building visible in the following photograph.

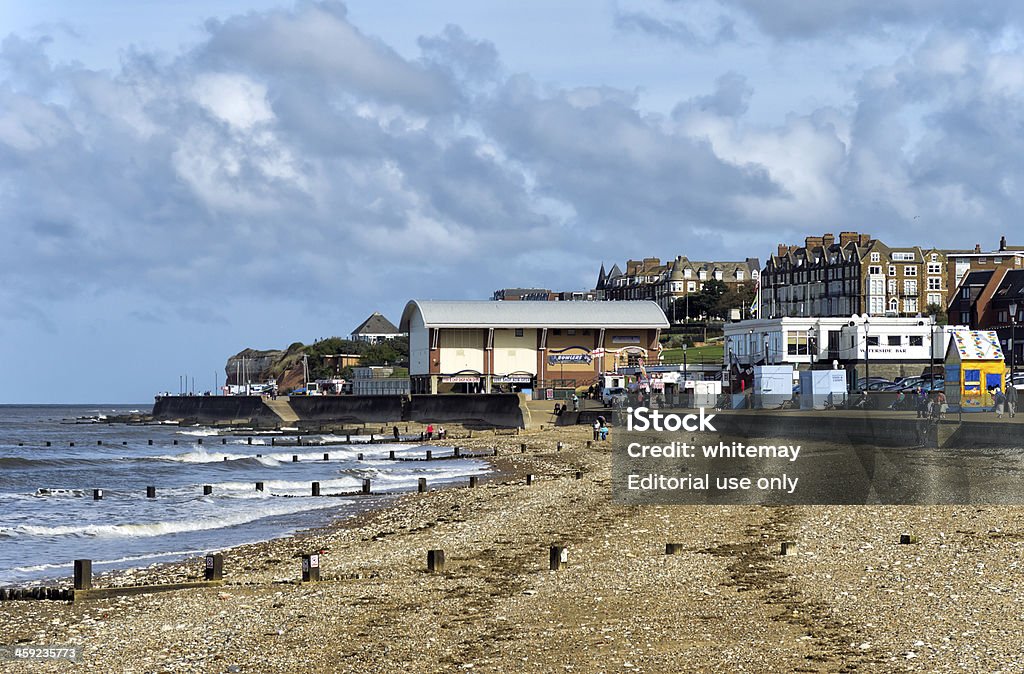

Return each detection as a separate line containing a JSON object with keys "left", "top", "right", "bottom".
{"left": 407, "top": 393, "right": 529, "bottom": 428}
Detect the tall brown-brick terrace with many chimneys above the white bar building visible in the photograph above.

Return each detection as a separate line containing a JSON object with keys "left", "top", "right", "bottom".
{"left": 761, "top": 231, "right": 948, "bottom": 318}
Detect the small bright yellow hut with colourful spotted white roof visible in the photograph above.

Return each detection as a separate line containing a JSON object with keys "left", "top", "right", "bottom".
{"left": 945, "top": 330, "right": 1007, "bottom": 412}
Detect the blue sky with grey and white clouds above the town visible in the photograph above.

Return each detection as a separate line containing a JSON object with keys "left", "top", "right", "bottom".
{"left": 0, "top": 0, "right": 1024, "bottom": 404}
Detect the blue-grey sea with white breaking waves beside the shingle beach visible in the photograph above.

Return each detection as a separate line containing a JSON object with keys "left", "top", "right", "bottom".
{"left": 0, "top": 405, "right": 489, "bottom": 587}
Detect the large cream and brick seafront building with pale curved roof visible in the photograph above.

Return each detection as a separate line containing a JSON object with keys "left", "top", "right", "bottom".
{"left": 399, "top": 300, "right": 669, "bottom": 393}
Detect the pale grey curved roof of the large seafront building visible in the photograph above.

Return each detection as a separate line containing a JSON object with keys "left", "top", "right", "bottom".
{"left": 399, "top": 299, "right": 669, "bottom": 332}
